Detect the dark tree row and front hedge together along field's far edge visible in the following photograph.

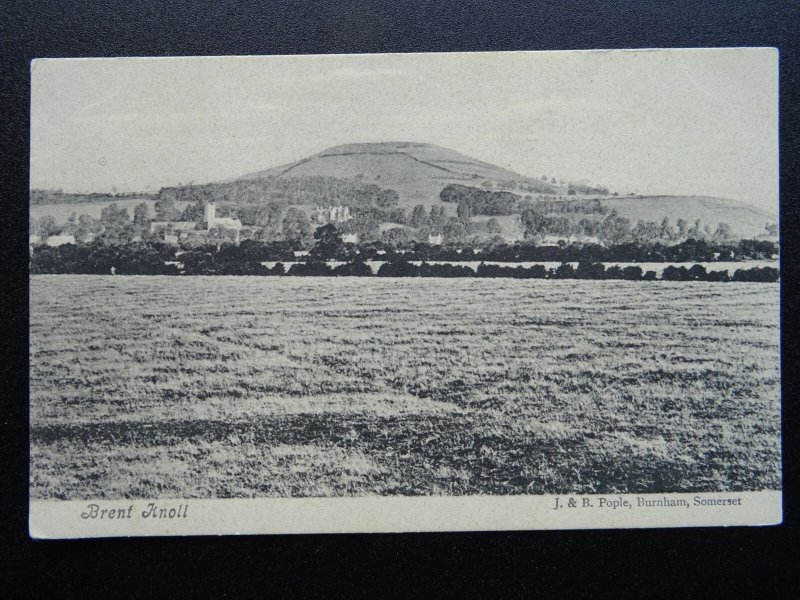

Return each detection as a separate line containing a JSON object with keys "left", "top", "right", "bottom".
{"left": 30, "top": 224, "right": 777, "bottom": 281}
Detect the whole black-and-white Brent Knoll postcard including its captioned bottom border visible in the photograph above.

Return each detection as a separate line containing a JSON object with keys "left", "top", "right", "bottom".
{"left": 29, "top": 48, "right": 782, "bottom": 538}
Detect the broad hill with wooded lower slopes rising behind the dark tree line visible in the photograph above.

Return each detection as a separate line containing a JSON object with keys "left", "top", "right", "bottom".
{"left": 31, "top": 142, "right": 778, "bottom": 242}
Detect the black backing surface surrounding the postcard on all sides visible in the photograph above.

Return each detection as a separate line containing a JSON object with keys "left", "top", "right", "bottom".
{"left": 0, "top": 0, "right": 800, "bottom": 598}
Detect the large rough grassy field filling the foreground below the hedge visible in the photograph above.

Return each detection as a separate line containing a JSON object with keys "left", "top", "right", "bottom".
{"left": 30, "top": 276, "right": 781, "bottom": 499}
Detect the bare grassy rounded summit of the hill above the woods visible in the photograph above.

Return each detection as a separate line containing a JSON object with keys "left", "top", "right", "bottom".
{"left": 234, "top": 142, "right": 556, "bottom": 208}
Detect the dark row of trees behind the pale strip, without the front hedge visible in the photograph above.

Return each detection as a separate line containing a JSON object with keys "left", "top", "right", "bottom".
{"left": 31, "top": 231, "right": 778, "bottom": 273}
